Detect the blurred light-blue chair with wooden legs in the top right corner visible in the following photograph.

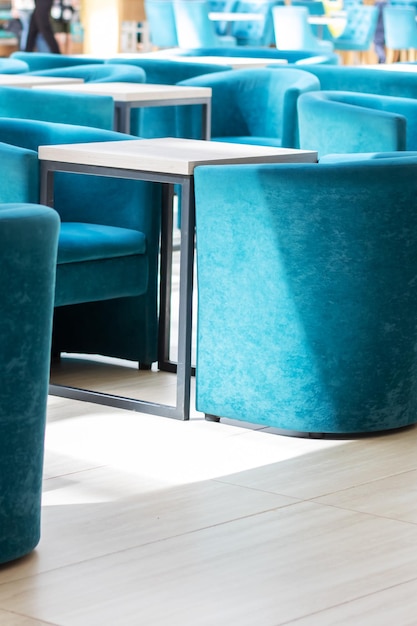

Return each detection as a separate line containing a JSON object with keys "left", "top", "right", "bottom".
{"left": 382, "top": 5, "right": 417, "bottom": 63}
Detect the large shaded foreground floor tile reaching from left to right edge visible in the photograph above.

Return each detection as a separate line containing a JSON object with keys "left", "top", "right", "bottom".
{"left": 0, "top": 502, "right": 417, "bottom": 626}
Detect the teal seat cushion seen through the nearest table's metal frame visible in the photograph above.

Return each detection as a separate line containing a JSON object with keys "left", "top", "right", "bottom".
{"left": 58, "top": 222, "right": 146, "bottom": 265}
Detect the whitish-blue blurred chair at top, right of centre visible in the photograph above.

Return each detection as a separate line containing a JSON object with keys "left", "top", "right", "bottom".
{"left": 272, "top": 6, "right": 333, "bottom": 53}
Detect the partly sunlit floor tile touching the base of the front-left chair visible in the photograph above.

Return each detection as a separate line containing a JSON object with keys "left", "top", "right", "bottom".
{"left": 0, "top": 468, "right": 297, "bottom": 584}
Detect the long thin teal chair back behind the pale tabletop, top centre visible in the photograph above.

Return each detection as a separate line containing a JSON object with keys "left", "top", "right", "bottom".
{"left": 164, "top": 46, "right": 340, "bottom": 63}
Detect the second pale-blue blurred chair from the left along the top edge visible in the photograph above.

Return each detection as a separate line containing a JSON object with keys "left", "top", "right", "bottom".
{"left": 174, "top": 0, "right": 236, "bottom": 48}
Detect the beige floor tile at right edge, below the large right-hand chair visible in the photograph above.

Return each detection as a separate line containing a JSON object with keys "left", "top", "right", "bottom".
{"left": 214, "top": 427, "right": 417, "bottom": 499}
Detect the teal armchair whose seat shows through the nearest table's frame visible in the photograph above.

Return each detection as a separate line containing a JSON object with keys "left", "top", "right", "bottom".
{"left": 0, "top": 118, "right": 161, "bottom": 366}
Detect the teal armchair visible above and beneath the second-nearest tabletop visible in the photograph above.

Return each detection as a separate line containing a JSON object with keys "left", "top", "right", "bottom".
{"left": 108, "top": 57, "right": 232, "bottom": 138}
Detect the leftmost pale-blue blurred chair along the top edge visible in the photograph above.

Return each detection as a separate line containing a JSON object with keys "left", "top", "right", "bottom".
{"left": 144, "top": 0, "right": 178, "bottom": 48}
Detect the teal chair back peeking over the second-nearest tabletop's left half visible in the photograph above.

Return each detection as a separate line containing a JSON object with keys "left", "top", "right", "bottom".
{"left": 26, "top": 63, "right": 146, "bottom": 83}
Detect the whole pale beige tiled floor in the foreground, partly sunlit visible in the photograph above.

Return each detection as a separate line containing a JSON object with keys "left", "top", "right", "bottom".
{"left": 0, "top": 382, "right": 417, "bottom": 626}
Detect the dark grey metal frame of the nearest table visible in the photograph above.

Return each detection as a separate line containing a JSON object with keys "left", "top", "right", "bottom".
{"left": 40, "top": 160, "right": 195, "bottom": 420}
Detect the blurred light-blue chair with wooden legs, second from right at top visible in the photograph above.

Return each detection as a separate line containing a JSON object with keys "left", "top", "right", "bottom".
{"left": 326, "top": 3, "right": 378, "bottom": 65}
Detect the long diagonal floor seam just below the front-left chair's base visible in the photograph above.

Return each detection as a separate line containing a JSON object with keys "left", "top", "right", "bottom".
{"left": 0, "top": 502, "right": 306, "bottom": 584}
